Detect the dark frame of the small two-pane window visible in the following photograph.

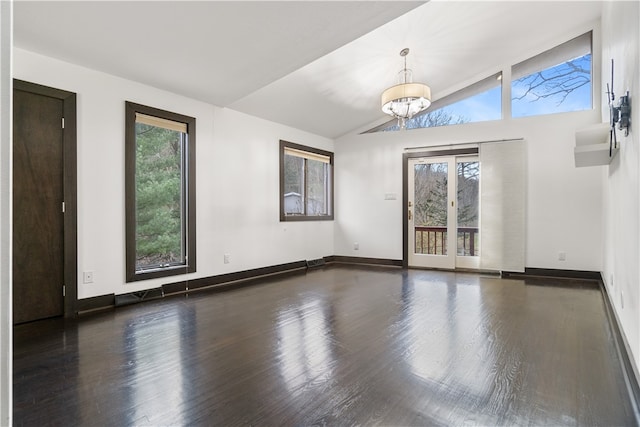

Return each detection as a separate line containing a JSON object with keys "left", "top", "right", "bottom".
{"left": 280, "top": 140, "right": 334, "bottom": 222}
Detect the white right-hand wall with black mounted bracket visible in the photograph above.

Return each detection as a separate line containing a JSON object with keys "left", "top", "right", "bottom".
{"left": 602, "top": 2, "right": 640, "bottom": 372}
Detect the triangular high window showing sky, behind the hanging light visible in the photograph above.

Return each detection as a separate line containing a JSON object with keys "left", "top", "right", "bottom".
{"left": 368, "top": 73, "right": 502, "bottom": 132}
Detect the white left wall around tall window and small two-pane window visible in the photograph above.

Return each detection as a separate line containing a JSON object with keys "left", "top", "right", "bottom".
{"left": 14, "top": 49, "right": 333, "bottom": 298}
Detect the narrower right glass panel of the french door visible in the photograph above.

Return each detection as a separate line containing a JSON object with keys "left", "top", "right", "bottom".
{"left": 456, "top": 161, "right": 480, "bottom": 256}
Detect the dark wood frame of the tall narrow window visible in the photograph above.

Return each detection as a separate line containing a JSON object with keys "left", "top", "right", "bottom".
{"left": 125, "top": 101, "right": 196, "bottom": 283}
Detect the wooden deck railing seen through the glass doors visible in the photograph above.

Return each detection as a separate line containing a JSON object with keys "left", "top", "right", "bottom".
{"left": 415, "top": 227, "right": 480, "bottom": 256}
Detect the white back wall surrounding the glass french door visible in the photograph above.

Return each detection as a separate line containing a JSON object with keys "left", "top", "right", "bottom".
{"left": 335, "top": 110, "right": 602, "bottom": 271}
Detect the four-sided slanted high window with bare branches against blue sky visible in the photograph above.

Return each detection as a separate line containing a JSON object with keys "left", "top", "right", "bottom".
{"left": 511, "top": 32, "right": 593, "bottom": 117}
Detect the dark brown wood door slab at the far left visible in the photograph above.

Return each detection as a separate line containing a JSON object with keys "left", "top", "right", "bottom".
{"left": 13, "top": 89, "right": 64, "bottom": 323}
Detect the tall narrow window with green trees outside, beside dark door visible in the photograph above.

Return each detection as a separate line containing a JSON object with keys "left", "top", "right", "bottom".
{"left": 125, "top": 102, "right": 196, "bottom": 282}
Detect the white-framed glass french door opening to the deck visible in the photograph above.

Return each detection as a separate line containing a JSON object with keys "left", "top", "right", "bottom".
{"left": 407, "top": 156, "right": 480, "bottom": 269}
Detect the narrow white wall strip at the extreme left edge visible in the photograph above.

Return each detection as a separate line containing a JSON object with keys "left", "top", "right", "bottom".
{"left": 0, "top": 1, "right": 13, "bottom": 426}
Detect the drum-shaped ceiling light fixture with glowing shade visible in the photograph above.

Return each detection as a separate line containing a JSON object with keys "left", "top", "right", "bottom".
{"left": 382, "top": 47, "right": 431, "bottom": 129}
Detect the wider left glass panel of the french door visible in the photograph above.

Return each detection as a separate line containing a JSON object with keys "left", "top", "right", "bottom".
{"left": 414, "top": 162, "right": 448, "bottom": 255}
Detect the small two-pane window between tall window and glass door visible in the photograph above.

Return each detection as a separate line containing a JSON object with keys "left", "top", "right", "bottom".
{"left": 280, "top": 141, "right": 333, "bottom": 221}
